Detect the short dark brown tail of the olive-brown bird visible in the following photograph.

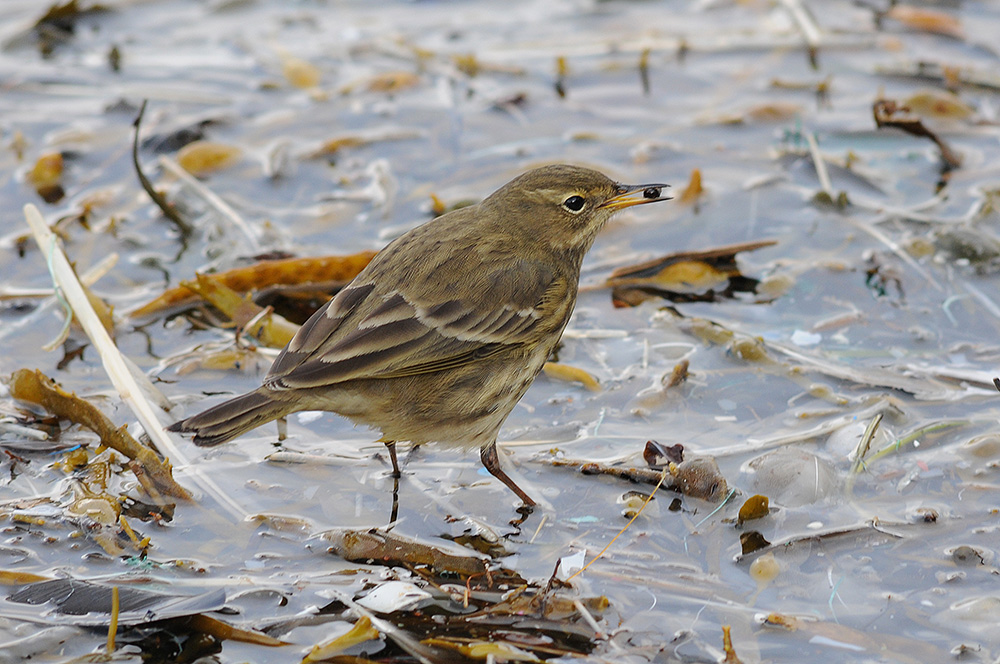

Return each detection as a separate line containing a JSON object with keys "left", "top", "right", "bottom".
{"left": 167, "top": 389, "right": 295, "bottom": 447}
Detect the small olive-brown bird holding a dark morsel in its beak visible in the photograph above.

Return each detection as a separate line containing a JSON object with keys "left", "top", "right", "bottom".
{"left": 168, "top": 164, "right": 670, "bottom": 509}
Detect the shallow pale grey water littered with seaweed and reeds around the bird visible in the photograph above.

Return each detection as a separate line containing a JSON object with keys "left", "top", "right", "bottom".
{"left": 0, "top": 0, "right": 1000, "bottom": 662}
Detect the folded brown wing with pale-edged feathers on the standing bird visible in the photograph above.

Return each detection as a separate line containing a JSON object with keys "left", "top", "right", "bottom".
{"left": 265, "top": 255, "right": 575, "bottom": 389}
